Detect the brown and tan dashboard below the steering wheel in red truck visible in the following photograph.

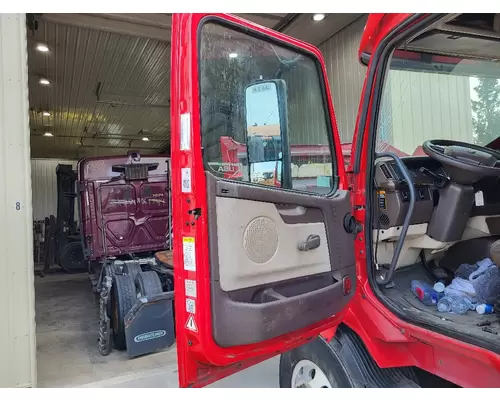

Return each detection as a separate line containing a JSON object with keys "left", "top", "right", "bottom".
{"left": 373, "top": 156, "right": 500, "bottom": 266}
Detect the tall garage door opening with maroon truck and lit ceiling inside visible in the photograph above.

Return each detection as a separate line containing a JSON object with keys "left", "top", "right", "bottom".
{"left": 27, "top": 14, "right": 176, "bottom": 387}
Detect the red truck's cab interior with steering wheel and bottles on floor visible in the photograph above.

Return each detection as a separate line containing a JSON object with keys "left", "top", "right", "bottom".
{"left": 367, "top": 14, "right": 500, "bottom": 352}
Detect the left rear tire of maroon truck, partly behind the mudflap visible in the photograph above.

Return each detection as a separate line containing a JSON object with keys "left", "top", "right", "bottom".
{"left": 111, "top": 275, "right": 137, "bottom": 350}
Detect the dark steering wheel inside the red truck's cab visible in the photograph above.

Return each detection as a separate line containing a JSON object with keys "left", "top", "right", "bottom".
{"left": 422, "top": 139, "right": 500, "bottom": 185}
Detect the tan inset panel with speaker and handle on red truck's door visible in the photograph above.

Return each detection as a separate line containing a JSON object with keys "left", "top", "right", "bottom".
{"left": 216, "top": 197, "right": 331, "bottom": 291}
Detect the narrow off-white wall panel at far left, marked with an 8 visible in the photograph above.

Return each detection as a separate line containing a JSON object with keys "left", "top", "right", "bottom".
{"left": 0, "top": 14, "right": 36, "bottom": 387}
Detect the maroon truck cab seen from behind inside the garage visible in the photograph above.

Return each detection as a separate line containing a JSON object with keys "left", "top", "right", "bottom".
{"left": 78, "top": 153, "right": 169, "bottom": 261}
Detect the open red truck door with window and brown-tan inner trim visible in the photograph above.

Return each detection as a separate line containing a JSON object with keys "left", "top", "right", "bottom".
{"left": 171, "top": 14, "right": 356, "bottom": 387}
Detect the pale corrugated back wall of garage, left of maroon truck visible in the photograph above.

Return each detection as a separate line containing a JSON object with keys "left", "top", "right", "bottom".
{"left": 31, "top": 159, "right": 78, "bottom": 220}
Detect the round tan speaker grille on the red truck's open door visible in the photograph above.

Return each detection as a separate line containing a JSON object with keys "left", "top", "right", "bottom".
{"left": 243, "top": 217, "right": 279, "bottom": 264}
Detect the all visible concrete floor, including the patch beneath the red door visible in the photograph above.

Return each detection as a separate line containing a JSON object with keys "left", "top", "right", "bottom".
{"left": 35, "top": 274, "right": 279, "bottom": 388}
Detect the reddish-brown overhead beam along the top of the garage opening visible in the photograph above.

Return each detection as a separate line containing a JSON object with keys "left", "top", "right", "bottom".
{"left": 41, "top": 14, "right": 171, "bottom": 42}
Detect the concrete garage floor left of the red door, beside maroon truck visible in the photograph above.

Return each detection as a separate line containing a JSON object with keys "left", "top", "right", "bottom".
{"left": 35, "top": 274, "right": 177, "bottom": 387}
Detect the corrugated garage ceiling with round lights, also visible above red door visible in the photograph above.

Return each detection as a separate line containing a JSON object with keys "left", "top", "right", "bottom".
{"left": 28, "top": 14, "right": 362, "bottom": 159}
